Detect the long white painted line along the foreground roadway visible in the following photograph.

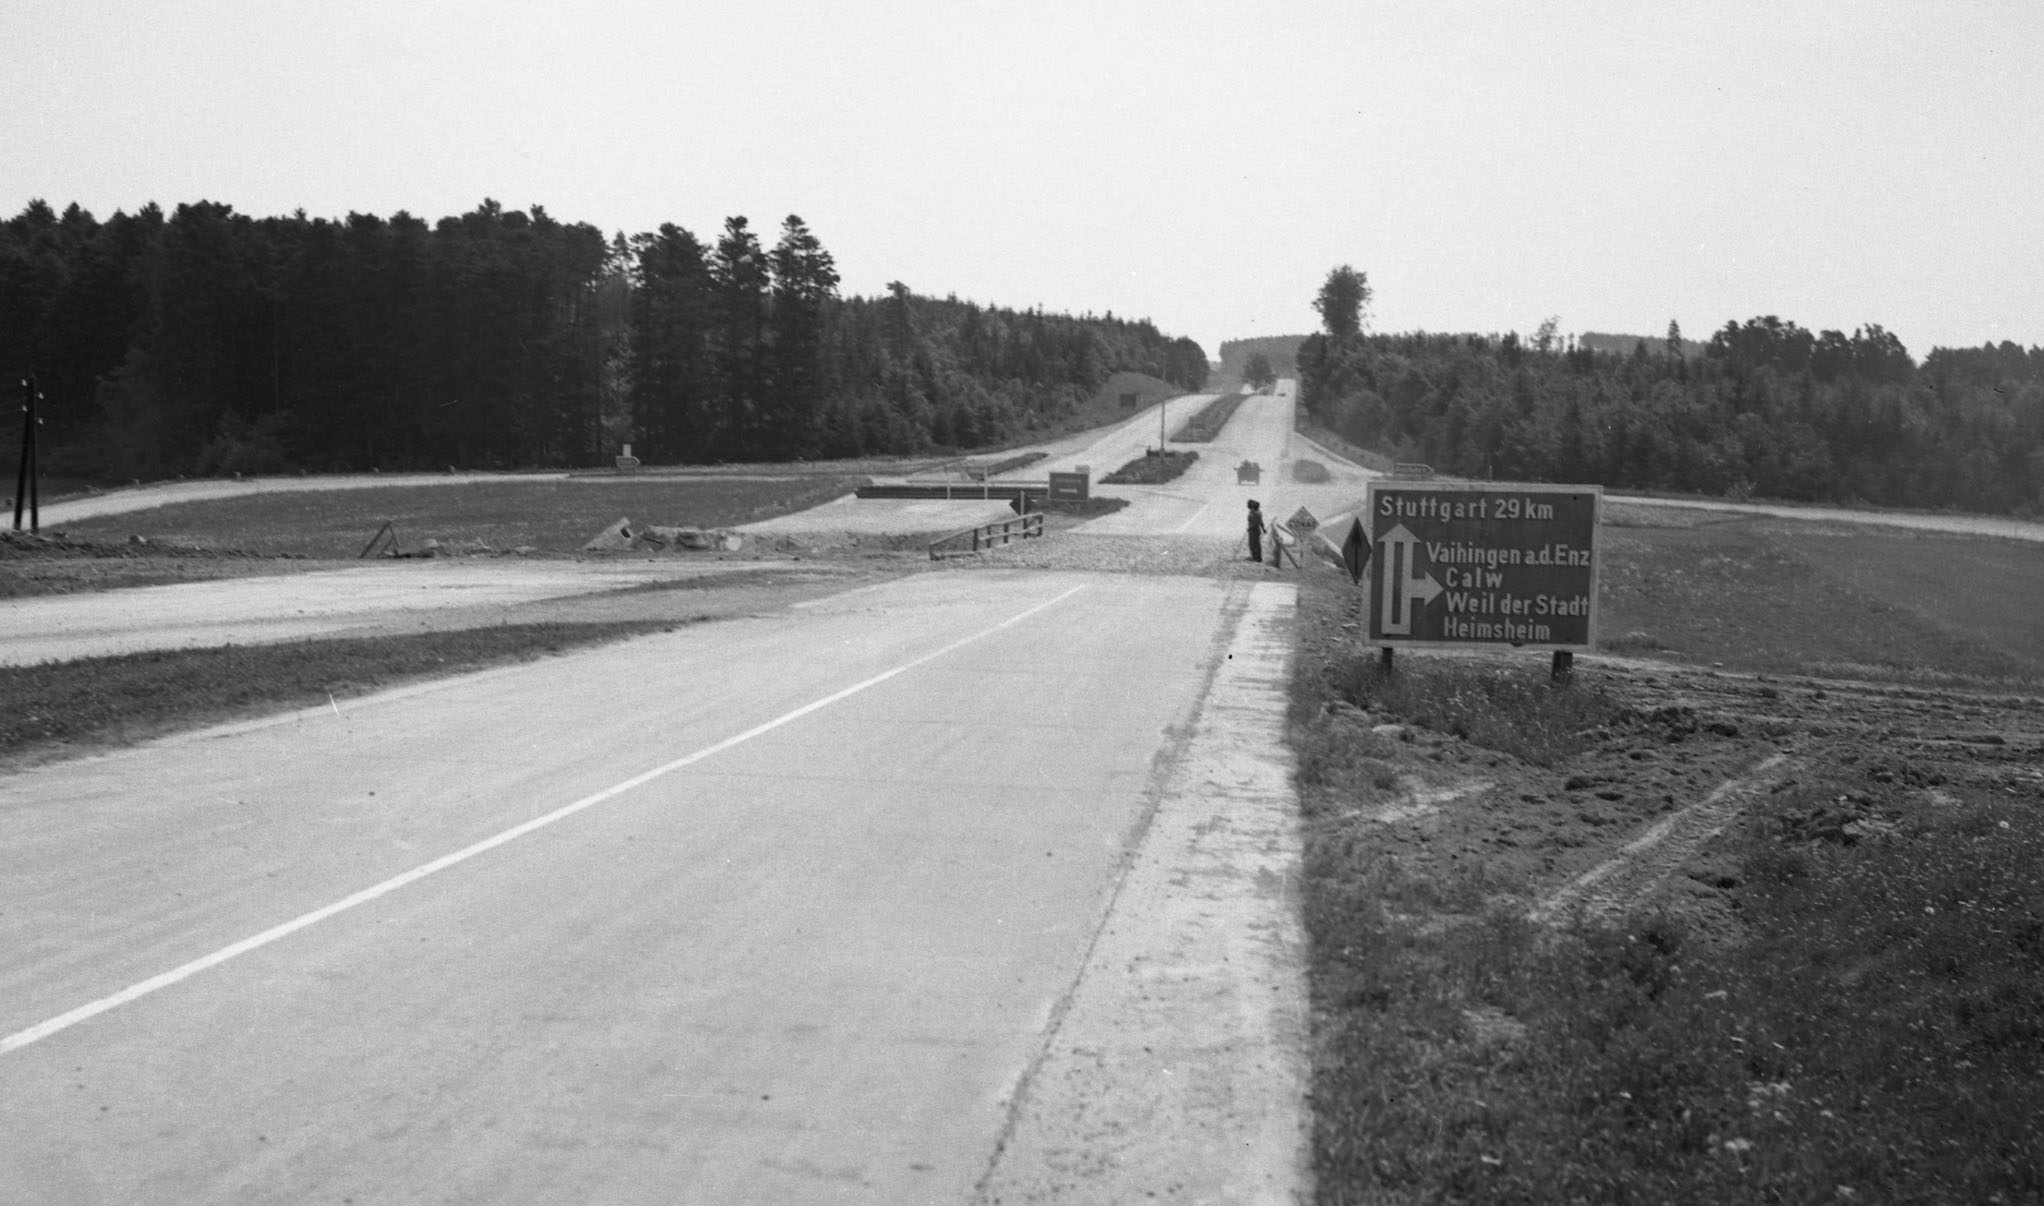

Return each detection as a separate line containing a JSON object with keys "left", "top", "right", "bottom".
{"left": 0, "top": 583, "right": 1085, "bottom": 1055}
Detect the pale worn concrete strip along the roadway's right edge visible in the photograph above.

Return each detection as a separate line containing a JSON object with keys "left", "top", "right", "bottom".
{"left": 979, "top": 583, "right": 1310, "bottom": 1206}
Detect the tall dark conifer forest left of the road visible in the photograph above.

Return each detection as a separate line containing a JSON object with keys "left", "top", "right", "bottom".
{"left": 0, "top": 200, "right": 1206, "bottom": 478}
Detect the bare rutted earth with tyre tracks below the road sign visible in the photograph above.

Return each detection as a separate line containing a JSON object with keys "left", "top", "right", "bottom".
{"left": 1302, "top": 584, "right": 2044, "bottom": 940}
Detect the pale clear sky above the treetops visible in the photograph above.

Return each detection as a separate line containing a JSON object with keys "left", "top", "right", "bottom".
{"left": 0, "top": 0, "right": 2044, "bottom": 358}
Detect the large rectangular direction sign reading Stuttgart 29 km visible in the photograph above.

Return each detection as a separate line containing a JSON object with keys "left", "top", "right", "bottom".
{"left": 1363, "top": 480, "right": 1605, "bottom": 652}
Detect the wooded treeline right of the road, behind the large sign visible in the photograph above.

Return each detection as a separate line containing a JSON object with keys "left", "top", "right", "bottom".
{"left": 1298, "top": 317, "right": 2044, "bottom": 515}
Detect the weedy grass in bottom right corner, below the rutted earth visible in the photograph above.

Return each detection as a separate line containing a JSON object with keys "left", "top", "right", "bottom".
{"left": 1308, "top": 805, "right": 2044, "bottom": 1204}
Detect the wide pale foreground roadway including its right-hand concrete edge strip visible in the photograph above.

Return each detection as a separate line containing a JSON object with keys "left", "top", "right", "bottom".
{"left": 0, "top": 404, "right": 1304, "bottom": 1204}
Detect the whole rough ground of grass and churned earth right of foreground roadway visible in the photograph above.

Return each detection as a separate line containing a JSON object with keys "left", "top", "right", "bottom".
{"left": 1290, "top": 564, "right": 2044, "bottom": 1202}
